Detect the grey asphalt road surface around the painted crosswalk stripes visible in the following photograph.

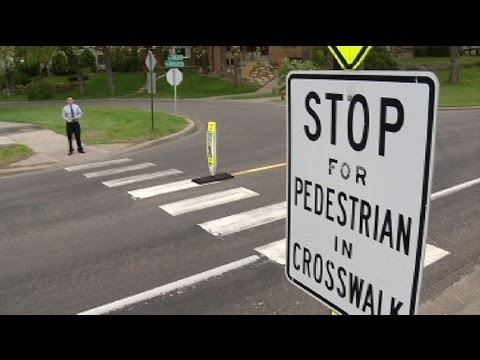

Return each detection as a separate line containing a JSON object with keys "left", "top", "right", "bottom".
{"left": 0, "top": 100, "right": 480, "bottom": 314}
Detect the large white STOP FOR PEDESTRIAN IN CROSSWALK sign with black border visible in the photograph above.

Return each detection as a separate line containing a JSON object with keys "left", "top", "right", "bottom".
{"left": 286, "top": 71, "right": 438, "bottom": 315}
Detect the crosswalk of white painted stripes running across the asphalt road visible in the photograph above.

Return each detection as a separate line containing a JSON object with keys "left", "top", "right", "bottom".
{"left": 65, "top": 158, "right": 449, "bottom": 266}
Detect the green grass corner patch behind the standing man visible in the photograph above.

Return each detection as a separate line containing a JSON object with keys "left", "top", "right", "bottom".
{"left": 0, "top": 106, "right": 187, "bottom": 144}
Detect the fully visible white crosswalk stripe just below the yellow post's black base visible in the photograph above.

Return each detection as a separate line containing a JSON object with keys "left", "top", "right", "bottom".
{"left": 159, "top": 187, "right": 258, "bottom": 216}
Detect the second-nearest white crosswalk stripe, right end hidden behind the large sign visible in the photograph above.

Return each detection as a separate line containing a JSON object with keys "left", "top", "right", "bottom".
{"left": 199, "top": 201, "right": 287, "bottom": 236}
